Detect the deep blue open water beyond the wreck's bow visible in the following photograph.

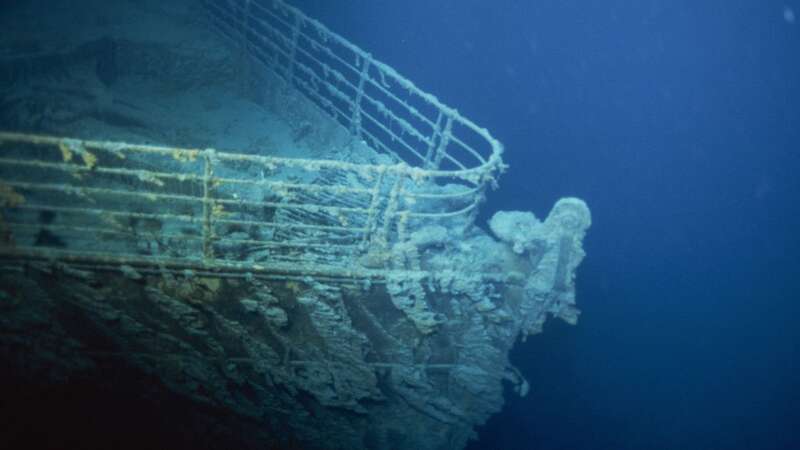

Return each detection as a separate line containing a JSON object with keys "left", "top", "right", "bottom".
{"left": 294, "top": 0, "right": 800, "bottom": 450}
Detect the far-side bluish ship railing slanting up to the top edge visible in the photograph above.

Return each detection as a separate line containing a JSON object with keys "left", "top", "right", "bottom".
{"left": 205, "top": 0, "right": 503, "bottom": 178}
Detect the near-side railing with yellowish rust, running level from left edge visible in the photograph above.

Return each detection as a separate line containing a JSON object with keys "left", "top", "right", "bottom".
{"left": 0, "top": 133, "right": 490, "bottom": 284}
